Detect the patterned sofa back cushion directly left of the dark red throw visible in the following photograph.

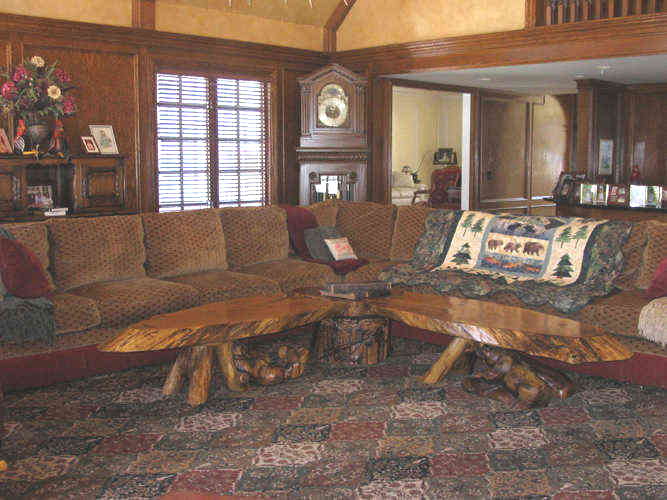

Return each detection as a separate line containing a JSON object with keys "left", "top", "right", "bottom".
{"left": 219, "top": 207, "right": 289, "bottom": 269}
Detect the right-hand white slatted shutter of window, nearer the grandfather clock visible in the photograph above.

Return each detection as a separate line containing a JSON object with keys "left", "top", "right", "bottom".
{"left": 217, "top": 78, "right": 268, "bottom": 206}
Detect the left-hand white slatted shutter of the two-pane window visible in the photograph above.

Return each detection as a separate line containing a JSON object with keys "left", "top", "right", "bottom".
{"left": 157, "top": 74, "right": 211, "bottom": 212}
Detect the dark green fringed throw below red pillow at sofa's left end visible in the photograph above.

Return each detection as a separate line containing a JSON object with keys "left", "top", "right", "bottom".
{"left": 0, "top": 227, "right": 56, "bottom": 343}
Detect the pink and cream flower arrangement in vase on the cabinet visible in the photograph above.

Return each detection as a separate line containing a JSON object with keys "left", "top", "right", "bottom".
{"left": 0, "top": 56, "right": 76, "bottom": 125}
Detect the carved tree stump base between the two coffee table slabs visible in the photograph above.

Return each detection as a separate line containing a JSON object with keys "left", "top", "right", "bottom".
{"left": 313, "top": 315, "right": 391, "bottom": 365}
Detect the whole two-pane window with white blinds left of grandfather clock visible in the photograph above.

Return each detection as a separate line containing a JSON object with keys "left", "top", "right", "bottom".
{"left": 156, "top": 73, "right": 269, "bottom": 212}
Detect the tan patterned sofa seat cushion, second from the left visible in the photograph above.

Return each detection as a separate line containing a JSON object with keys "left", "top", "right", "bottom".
{"left": 71, "top": 278, "right": 199, "bottom": 326}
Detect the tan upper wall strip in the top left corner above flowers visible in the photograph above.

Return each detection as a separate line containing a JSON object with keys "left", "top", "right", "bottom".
{"left": 0, "top": 0, "right": 132, "bottom": 26}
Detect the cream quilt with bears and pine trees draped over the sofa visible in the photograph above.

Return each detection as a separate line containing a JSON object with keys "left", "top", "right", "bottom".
{"left": 436, "top": 211, "right": 607, "bottom": 286}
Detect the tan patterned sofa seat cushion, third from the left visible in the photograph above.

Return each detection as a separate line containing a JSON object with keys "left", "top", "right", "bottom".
{"left": 168, "top": 271, "right": 280, "bottom": 304}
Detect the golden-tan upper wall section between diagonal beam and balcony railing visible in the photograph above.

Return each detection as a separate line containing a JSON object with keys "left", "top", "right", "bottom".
{"left": 337, "top": 0, "right": 525, "bottom": 50}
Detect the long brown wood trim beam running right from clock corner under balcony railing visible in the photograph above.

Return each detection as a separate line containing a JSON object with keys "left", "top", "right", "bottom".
{"left": 332, "top": 13, "right": 667, "bottom": 75}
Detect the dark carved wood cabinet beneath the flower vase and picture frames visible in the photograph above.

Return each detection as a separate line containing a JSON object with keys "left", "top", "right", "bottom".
{"left": 0, "top": 155, "right": 127, "bottom": 220}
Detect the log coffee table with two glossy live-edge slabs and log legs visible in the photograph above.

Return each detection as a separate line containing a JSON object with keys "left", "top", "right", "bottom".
{"left": 100, "top": 290, "right": 633, "bottom": 405}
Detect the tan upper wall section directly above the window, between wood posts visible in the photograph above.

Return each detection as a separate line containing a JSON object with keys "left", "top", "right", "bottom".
{"left": 155, "top": 2, "right": 324, "bottom": 50}
